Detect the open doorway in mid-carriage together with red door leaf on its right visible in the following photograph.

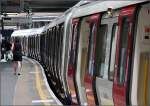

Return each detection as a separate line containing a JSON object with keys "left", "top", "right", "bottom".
{"left": 76, "top": 14, "right": 100, "bottom": 105}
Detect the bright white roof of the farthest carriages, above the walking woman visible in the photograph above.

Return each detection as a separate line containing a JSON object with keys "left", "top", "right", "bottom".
{"left": 11, "top": 27, "right": 45, "bottom": 37}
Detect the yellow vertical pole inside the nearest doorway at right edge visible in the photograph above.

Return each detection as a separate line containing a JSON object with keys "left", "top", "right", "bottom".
{"left": 144, "top": 58, "right": 148, "bottom": 106}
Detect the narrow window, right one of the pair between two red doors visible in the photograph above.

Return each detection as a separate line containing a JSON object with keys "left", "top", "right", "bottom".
{"left": 109, "top": 24, "right": 118, "bottom": 81}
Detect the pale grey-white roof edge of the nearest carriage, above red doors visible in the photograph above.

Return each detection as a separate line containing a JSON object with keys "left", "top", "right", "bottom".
{"left": 73, "top": 0, "right": 149, "bottom": 18}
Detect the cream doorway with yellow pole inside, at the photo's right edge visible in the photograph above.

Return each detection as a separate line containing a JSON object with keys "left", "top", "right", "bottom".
{"left": 131, "top": 3, "right": 150, "bottom": 106}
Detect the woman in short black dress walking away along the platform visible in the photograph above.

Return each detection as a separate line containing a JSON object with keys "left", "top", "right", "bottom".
{"left": 11, "top": 38, "right": 22, "bottom": 75}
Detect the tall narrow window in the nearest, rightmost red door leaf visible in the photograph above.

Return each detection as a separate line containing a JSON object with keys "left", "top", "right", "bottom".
{"left": 117, "top": 17, "right": 129, "bottom": 85}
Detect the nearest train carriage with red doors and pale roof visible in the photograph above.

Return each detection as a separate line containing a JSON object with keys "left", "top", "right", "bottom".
{"left": 68, "top": 1, "right": 150, "bottom": 105}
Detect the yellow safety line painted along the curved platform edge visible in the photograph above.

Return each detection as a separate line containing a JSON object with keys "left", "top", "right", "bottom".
{"left": 35, "top": 65, "right": 50, "bottom": 105}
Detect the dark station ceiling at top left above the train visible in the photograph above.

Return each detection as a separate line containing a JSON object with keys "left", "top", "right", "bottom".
{"left": 0, "top": 0, "right": 80, "bottom": 13}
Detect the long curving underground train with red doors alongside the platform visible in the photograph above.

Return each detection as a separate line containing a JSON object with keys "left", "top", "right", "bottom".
{"left": 14, "top": 0, "right": 150, "bottom": 106}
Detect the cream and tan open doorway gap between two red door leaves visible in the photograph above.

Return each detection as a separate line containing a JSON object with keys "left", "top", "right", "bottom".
{"left": 76, "top": 17, "right": 90, "bottom": 104}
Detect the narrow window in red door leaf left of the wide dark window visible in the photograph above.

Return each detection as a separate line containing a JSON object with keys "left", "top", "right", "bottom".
{"left": 87, "top": 24, "right": 96, "bottom": 76}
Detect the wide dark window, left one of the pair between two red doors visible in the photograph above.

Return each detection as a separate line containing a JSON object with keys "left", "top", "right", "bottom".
{"left": 95, "top": 24, "right": 108, "bottom": 77}
